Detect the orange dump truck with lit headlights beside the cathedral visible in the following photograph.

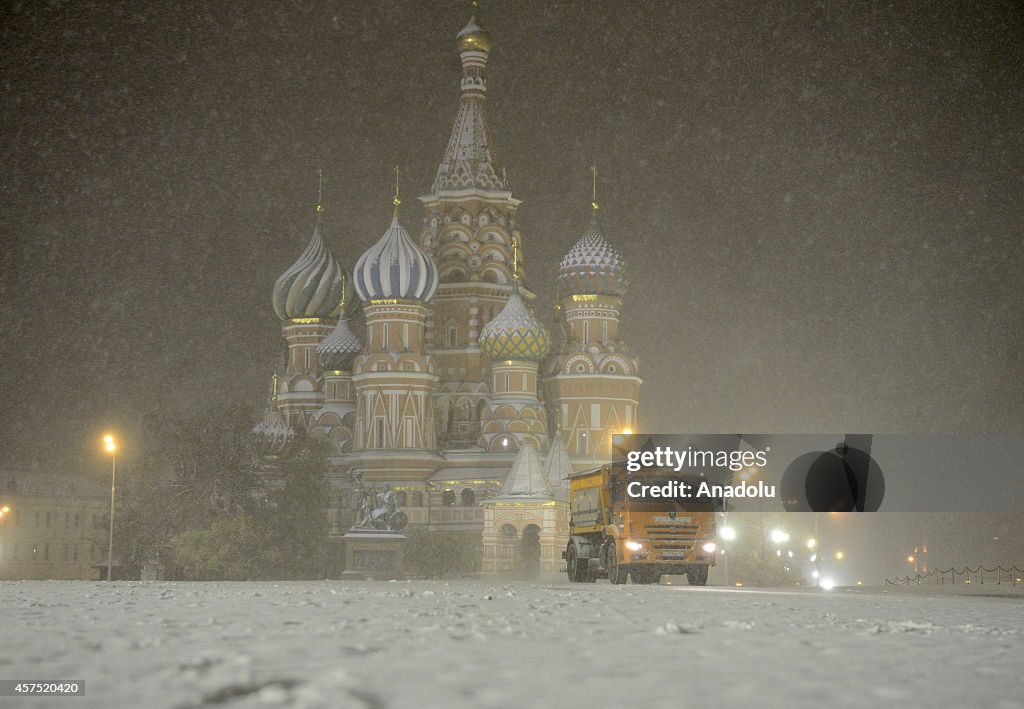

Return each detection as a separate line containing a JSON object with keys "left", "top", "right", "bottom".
{"left": 563, "top": 464, "right": 720, "bottom": 586}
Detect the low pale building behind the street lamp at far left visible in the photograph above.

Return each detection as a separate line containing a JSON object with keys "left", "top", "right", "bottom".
{"left": 0, "top": 471, "right": 111, "bottom": 581}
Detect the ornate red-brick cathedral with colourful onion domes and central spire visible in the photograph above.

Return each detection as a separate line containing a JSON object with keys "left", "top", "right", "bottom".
{"left": 254, "top": 9, "right": 641, "bottom": 574}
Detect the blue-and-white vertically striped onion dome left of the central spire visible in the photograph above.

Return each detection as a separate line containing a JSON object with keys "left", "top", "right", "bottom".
{"left": 352, "top": 214, "right": 437, "bottom": 302}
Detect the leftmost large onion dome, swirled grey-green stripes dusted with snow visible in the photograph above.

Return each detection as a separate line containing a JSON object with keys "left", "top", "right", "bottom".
{"left": 273, "top": 222, "right": 342, "bottom": 320}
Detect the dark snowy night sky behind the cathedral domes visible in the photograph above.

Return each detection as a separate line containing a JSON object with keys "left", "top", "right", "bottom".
{"left": 0, "top": 0, "right": 1024, "bottom": 467}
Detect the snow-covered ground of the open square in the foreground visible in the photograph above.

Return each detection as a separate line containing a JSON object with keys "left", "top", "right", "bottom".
{"left": 0, "top": 581, "right": 1024, "bottom": 709}
